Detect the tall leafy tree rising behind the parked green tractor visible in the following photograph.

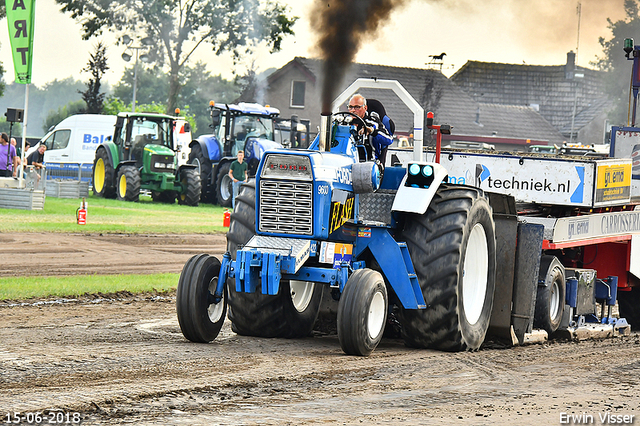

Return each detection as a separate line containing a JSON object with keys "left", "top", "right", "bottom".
{"left": 56, "top": 0, "right": 297, "bottom": 113}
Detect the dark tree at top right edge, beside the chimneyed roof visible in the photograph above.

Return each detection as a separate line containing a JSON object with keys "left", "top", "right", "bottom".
{"left": 594, "top": 0, "right": 640, "bottom": 126}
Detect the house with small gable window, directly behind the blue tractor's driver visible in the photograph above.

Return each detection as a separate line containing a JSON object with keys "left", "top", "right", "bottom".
{"left": 241, "top": 57, "right": 563, "bottom": 149}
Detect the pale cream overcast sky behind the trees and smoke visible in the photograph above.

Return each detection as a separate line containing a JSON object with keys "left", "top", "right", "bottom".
{"left": 0, "top": 0, "right": 640, "bottom": 86}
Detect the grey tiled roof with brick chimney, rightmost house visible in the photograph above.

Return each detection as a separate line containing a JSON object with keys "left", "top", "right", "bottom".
{"left": 450, "top": 52, "right": 611, "bottom": 144}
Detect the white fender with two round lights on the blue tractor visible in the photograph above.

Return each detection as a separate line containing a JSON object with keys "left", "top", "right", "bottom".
{"left": 391, "top": 161, "right": 448, "bottom": 214}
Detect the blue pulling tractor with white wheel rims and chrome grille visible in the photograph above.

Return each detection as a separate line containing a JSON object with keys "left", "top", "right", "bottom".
{"left": 177, "top": 81, "right": 496, "bottom": 356}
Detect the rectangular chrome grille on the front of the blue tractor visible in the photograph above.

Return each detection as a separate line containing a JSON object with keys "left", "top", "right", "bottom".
{"left": 258, "top": 179, "right": 313, "bottom": 235}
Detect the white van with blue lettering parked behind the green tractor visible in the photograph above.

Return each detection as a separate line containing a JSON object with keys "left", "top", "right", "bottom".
{"left": 29, "top": 114, "right": 116, "bottom": 181}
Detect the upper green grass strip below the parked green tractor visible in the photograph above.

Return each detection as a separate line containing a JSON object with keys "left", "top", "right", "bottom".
{"left": 0, "top": 196, "right": 226, "bottom": 234}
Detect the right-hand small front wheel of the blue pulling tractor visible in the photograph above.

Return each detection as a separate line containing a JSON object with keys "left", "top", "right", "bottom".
{"left": 338, "top": 269, "right": 389, "bottom": 356}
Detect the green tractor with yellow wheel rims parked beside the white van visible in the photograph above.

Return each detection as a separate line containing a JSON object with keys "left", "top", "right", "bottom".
{"left": 93, "top": 113, "right": 202, "bottom": 206}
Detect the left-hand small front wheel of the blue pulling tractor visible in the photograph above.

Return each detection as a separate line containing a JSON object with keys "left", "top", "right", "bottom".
{"left": 176, "top": 254, "right": 227, "bottom": 343}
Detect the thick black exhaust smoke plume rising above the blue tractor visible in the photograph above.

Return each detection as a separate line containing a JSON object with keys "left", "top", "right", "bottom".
{"left": 312, "top": 0, "right": 407, "bottom": 114}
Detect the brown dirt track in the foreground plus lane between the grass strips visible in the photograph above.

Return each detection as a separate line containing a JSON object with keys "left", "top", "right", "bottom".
{"left": 0, "top": 234, "right": 640, "bottom": 425}
